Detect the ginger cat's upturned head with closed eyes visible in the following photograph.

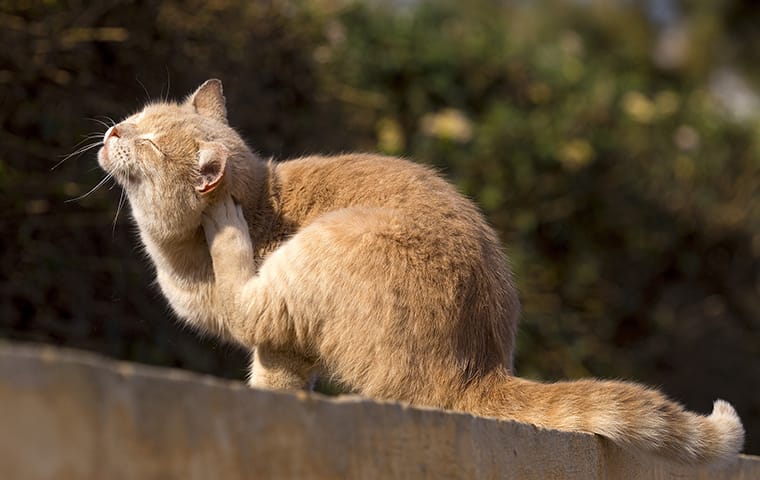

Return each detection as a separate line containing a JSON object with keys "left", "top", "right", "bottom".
{"left": 98, "top": 80, "right": 251, "bottom": 242}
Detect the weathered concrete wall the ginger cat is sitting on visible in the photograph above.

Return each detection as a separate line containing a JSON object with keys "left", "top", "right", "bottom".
{"left": 0, "top": 343, "right": 760, "bottom": 480}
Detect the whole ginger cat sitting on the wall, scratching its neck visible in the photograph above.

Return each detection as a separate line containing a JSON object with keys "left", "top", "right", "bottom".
{"left": 98, "top": 79, "right": 744, "bottom": 463}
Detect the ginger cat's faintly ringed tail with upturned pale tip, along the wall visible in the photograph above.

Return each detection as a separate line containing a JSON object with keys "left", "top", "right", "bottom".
{"left": 462, "top": 373, "right": 744, "bottom": 463}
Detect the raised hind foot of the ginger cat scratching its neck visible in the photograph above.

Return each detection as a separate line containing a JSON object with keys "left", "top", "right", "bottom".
{"left": 202, "top": 195, "right": 256, "bottom": 322}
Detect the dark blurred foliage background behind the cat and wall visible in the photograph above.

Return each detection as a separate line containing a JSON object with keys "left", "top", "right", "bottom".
{"left": 0, "top": 0, "right": 760, "bottom": 453}
